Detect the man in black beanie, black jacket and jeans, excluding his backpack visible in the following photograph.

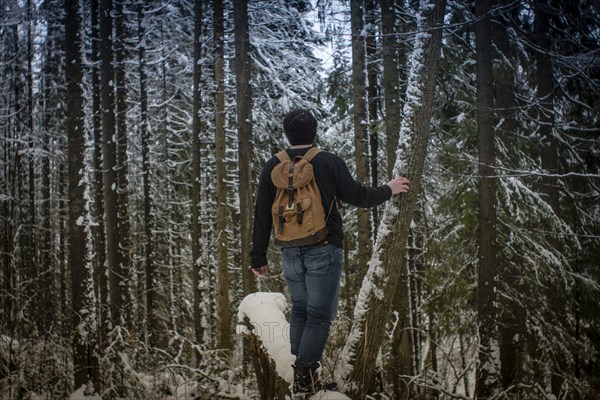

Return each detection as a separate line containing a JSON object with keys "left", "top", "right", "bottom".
{"left": 251, "top": 109, "right": 409, "bottom": 394}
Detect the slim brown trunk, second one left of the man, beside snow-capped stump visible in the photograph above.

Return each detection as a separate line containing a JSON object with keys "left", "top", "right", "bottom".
{"left": 213, "top": 0, "right": 233, "bottom": 350}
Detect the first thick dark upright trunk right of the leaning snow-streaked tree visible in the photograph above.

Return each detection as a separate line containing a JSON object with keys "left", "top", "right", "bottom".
{"left": 475, "top": 0, "right": 501, "bottom": 399}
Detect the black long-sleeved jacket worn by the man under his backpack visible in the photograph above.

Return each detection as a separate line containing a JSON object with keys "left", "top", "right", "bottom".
{"left": 250, "top": 147, "right": 392, "bottom": 268}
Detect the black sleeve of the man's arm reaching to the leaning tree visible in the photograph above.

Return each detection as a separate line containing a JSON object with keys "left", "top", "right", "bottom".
{"left": 334, "top": 156, "right": 392, "bottom": 208}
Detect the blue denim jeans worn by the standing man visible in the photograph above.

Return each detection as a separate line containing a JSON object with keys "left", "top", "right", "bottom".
{"left": 282, "top": 244, "right": 342, "bottom": 367}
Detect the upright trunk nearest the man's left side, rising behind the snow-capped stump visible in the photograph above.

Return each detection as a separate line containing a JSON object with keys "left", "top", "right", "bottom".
{"left": 233, "top": 0, "right": 256, "bottom": 294}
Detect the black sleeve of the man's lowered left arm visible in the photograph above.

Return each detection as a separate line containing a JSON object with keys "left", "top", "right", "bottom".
{"left": 250, "top": 163, "right": 275, "bottom": 268}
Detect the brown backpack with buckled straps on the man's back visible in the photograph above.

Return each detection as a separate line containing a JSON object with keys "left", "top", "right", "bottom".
{"left": 271, "top": 147, "right": 327, "bottom": 247}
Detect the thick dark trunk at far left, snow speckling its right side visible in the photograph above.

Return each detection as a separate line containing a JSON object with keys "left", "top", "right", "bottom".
{"left": 65, "top": 0, "right": 99, "bottom": 388}
